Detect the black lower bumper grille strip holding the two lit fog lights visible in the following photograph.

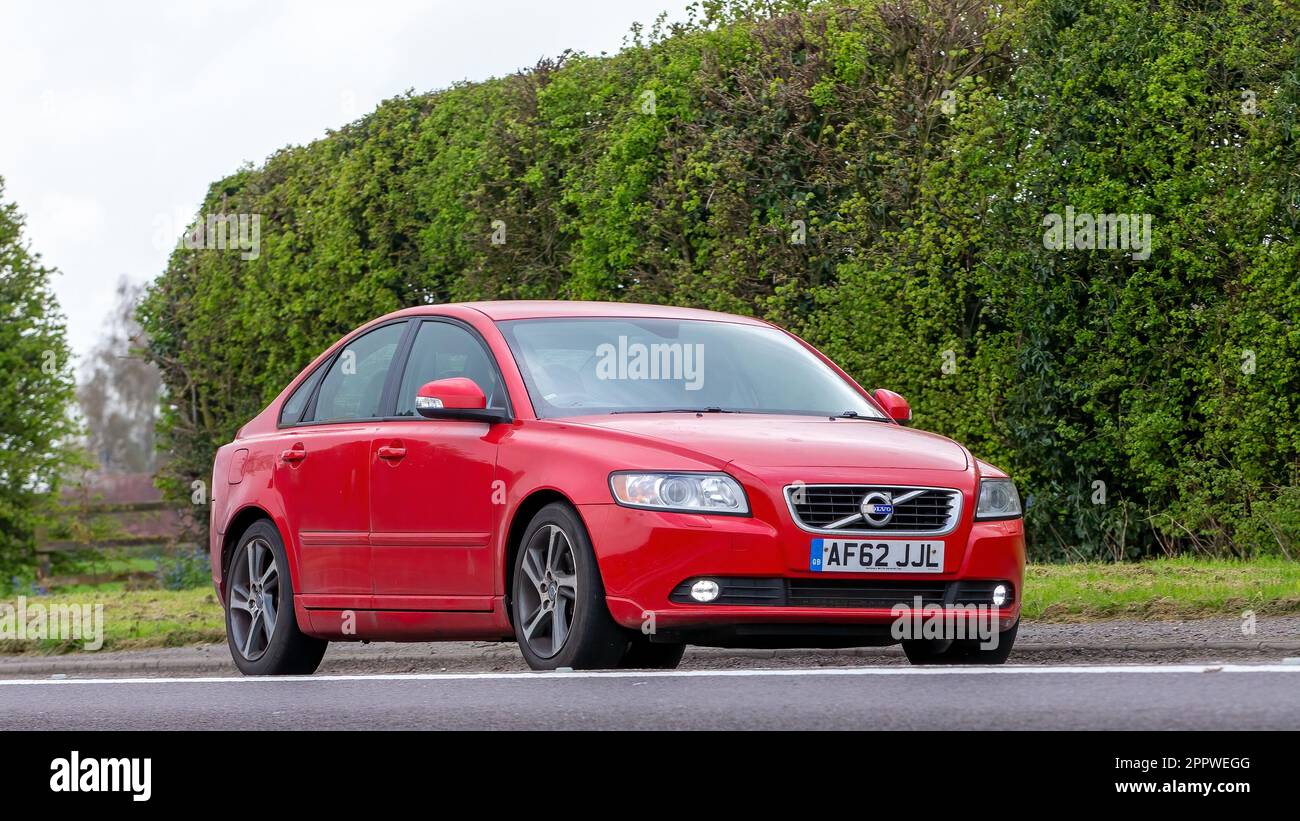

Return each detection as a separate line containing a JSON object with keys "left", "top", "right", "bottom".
{"left": 668, "top": 575, "right": 1010, "bottom": 609}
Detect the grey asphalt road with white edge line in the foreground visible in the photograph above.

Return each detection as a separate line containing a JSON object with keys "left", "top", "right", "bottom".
{"left": 0, "top": 664, "right": 1300, "bottom": 730}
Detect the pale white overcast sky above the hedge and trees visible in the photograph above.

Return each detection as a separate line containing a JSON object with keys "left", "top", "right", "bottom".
{"left": 0, "top": 0, "right": 688, "bottom": 366}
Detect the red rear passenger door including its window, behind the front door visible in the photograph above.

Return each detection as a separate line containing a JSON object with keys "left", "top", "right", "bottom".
{"left": 274, "top": 321, "right": 408, "bottom": 608}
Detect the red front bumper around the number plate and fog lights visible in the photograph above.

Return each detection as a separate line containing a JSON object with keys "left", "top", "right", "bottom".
{"left": 580, "top": 504, "right": 1024, "bottom": 647}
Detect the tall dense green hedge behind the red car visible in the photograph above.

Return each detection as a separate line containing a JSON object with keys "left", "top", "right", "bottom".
{"left": 140, "top": 0, "right": 1300, "bottom": 559}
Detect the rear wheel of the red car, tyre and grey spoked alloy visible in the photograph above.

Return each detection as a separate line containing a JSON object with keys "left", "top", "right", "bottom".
{"left": 225, "top": 520, "right": 329, "bottom": 676}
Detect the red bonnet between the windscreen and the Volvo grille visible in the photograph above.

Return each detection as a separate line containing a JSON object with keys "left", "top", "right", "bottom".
{"left": 566, "top": 413, "right": 967, "bottom": 470}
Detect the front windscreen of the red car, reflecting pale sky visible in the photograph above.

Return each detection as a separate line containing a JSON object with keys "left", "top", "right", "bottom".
{"left": 501, "top": 318, "right": 884, "bottom": 420}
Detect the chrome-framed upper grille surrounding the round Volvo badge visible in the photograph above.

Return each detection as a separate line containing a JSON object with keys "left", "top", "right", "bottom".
{"left": 785, "top": 485, "right": 962, "bottom": 535}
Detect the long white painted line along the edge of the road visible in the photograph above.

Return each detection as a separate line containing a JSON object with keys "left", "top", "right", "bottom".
{"left": 0, "top": 664, "right": 1300, "bottom": 687}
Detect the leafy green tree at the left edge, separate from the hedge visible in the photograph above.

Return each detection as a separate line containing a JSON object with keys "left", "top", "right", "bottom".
{"left": 0, "top": 178, "right": 75, "bottom": 577}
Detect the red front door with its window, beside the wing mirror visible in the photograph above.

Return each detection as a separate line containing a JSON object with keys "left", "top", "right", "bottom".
{"left": 371, "top": 318, "right": 507, "bottom": 611}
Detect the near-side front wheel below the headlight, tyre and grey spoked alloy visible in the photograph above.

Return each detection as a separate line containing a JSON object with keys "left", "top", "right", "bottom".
{"left": 510, "top": 501, "right": 628, "bottom": 670}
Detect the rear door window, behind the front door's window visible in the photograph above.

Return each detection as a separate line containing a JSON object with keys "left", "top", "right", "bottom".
{"left": 312, "top": 322, "right": 406, "bottom": 422}
